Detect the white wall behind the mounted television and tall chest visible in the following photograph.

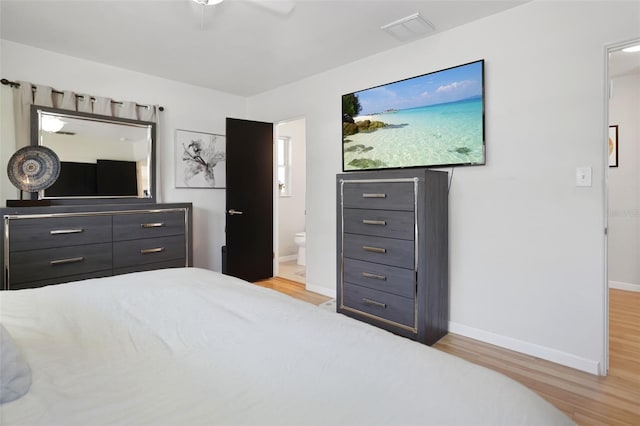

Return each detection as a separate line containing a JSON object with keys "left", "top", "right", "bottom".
{"left": 248, "top": 1, "right": 640, "bottom": 373}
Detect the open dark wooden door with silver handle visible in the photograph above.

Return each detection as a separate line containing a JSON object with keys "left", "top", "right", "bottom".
{"left": 226, "top": 118, "right": 273, "bottom": 281}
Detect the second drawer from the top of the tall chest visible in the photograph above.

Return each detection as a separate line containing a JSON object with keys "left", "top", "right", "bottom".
{"left": 343, "top": 209, "right": 415, "bottom": 240}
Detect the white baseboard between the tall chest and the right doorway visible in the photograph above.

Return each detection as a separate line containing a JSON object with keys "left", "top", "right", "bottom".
{"left": 449, "top": 321, "right": 602, "bottom": 375}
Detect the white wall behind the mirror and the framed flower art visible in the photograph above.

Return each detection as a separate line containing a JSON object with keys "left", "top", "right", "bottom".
{"left": 0, "top": 40, "right": 246, "bottom": 271}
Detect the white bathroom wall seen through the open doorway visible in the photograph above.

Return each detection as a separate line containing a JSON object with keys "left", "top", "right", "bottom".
{"left": 277, "top": 118, "right": 307, "bottom": 257}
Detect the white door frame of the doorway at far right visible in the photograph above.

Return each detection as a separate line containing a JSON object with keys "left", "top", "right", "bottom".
{"left": 599, "top": 38, "right": 640, "bottom": 376}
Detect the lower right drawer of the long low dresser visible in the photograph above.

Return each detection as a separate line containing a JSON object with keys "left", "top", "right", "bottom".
{"left": 113, "top": 235, "right": 186, "bottom": 269}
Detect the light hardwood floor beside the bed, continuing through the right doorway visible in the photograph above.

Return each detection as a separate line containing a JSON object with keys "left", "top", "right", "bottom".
{"left": 256, "top": 278, "right": 640, "bottom": 426}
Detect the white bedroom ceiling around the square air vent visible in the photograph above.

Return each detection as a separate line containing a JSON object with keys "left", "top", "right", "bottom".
{"left": 0, "top": 0, "right": 528, "bottom": 96}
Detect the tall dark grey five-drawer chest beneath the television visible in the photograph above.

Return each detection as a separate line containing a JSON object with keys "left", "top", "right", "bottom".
{"left": 337, "top": 169, "right": 449, "bottom": 345}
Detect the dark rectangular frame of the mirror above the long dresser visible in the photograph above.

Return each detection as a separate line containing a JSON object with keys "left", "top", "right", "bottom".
{"left": 31, "top": 105, "right": 156, "bottom": 205}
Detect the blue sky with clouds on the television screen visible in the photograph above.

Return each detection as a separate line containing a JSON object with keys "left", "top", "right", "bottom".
{"left": 355, "top": 61, "right": 483, "bottom": 115}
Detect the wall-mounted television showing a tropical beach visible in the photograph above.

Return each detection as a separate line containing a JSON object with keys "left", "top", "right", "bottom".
{"left": 342, "top": 60, "right": 485, "bottom": 171}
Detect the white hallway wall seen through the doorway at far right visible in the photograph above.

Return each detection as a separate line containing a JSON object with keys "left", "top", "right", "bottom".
{"left": 608, "top": 74, "right": 640, "bottom": 291}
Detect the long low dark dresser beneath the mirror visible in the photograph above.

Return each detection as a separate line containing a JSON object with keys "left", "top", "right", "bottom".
{"left": 0, "top": 203, "right": 193, "bottom": 290}
